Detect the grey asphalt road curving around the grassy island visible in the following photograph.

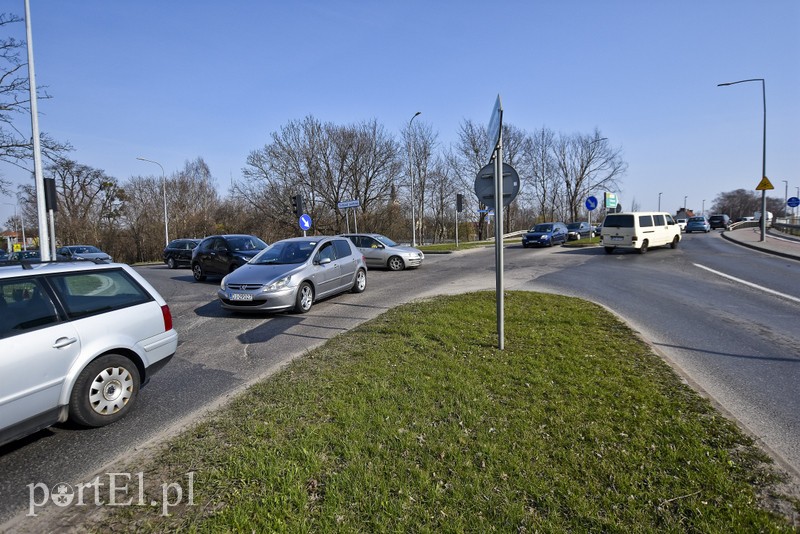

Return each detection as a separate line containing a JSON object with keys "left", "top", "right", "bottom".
{"left": 0, "top": 237, "right": 800, "bottom": 528}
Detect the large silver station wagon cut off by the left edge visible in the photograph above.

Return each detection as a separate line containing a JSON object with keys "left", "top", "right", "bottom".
{"left": 0, "top": 261, "right": 178, "bottom": 445}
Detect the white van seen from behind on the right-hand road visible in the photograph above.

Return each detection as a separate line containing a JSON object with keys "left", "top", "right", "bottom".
{"left": 602, "top": 211, "right": 681, "bottom": 254}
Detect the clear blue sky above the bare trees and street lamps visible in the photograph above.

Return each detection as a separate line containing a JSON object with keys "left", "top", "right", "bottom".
{"left": 0, "top": 0, "right": 800, "bottom": 221}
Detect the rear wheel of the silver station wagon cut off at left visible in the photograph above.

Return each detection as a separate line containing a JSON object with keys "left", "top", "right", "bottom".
{"left": 69, "top": 354, "right": 140, "bottom": 427}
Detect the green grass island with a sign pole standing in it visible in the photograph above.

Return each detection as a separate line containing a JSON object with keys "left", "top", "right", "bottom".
{"left": 92, "top": 292, "right": 792, "bottom": 532}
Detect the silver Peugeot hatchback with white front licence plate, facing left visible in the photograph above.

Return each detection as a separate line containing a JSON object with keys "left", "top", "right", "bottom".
{"left": 217, "top": 236, "right": 367, "bottom": 313}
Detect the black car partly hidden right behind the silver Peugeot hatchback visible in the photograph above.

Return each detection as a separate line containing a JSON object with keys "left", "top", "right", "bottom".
{"left": 192, "top": 234, "right": 267, "bottom": 282}
